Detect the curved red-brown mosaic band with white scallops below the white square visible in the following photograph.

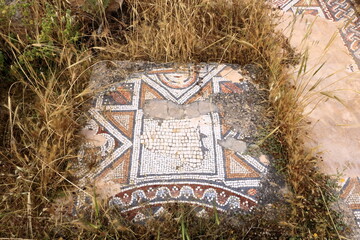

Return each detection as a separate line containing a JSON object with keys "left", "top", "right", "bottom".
{"left": 110, "top": 183, "right": 256, "bottom": 218}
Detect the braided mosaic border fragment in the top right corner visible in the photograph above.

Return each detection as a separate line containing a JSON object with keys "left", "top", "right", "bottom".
{"left": 270, "top": 0, "right": 360, "bottom": 68}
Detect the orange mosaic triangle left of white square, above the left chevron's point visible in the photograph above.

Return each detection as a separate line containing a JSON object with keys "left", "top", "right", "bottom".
{"left": 104, "top": 111, "right": 135, "bottom": 139}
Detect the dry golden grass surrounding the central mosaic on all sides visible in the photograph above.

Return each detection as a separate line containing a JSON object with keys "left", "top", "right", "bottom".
{"left": 0, "top": 0, "right": 346, "bottom": 239}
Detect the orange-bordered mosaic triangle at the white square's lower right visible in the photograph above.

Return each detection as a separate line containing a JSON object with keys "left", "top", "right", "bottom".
{"left": 224, "top": 150, "right": 260, "bottom": 178}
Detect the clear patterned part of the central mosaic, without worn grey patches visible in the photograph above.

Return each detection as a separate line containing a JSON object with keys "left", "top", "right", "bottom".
{"left": 79, "top": 64, "right": 267, "bottom": 214}
